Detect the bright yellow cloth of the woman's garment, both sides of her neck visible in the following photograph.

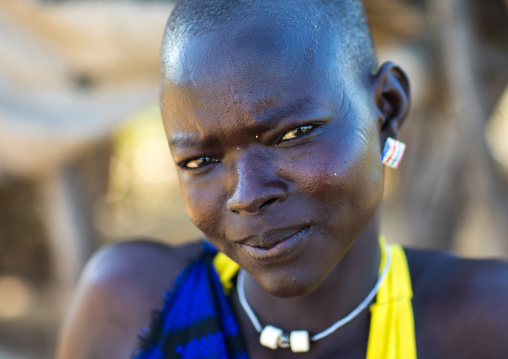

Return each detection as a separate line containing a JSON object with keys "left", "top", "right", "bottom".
{"left": 214, "top": 240, "right": 416, "bottom": 359}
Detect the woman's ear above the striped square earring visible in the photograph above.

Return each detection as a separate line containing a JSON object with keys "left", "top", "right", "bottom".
{"left": 373, "top": 62, "right": 411, "bottom": 145}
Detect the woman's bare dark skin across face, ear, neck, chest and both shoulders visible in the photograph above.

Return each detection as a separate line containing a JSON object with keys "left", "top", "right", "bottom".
{"left": 58, "top": 4, "right": 508, "bottom": 359}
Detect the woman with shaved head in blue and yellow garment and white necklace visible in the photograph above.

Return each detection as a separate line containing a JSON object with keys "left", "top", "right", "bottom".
{"left": 55, "top": 0, "right": 508, "bottom": 359}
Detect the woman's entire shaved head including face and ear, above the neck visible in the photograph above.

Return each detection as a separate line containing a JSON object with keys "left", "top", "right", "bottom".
{"left": 161, "top": 0, "right": 409, "bottom": 297}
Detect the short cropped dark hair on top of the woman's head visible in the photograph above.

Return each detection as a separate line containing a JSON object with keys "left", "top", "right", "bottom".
{"left": 162, "top": 0, "right": 378, "bottom": 80}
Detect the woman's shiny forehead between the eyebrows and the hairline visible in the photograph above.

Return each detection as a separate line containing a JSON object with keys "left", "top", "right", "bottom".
{"left": 162, "top": 13, "right": 364, "bottom": 136}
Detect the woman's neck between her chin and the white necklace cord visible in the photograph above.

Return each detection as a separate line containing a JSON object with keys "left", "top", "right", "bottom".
{"left": 240, "top": 215, "right": 381, "bottom": 334}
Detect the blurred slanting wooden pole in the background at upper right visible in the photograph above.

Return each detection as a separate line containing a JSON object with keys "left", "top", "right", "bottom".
{"left": 431, "top": 0, "right": 508, "bottom": 254}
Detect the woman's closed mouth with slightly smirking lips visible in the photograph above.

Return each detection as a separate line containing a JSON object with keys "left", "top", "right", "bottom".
{"left": 238, "top": 226, "right": 311, "bottom": 261}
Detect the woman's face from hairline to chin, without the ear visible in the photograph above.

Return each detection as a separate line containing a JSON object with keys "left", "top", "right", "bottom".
{"left": 162, "top": 25, "right": 383, "bottom": 297}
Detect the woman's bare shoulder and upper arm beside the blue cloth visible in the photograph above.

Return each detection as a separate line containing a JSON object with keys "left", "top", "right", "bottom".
{"left": 57, "top": 241, "right": 202, "bottom": 359}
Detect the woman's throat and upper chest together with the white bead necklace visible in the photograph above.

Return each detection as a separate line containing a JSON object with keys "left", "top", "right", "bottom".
{"left": 232, "top": 236, "right": 384, "bottom": 357}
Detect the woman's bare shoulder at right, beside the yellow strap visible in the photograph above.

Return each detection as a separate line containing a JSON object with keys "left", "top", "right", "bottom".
{"left": 406, "top": 250, "right": 508, "bottom": 358}
